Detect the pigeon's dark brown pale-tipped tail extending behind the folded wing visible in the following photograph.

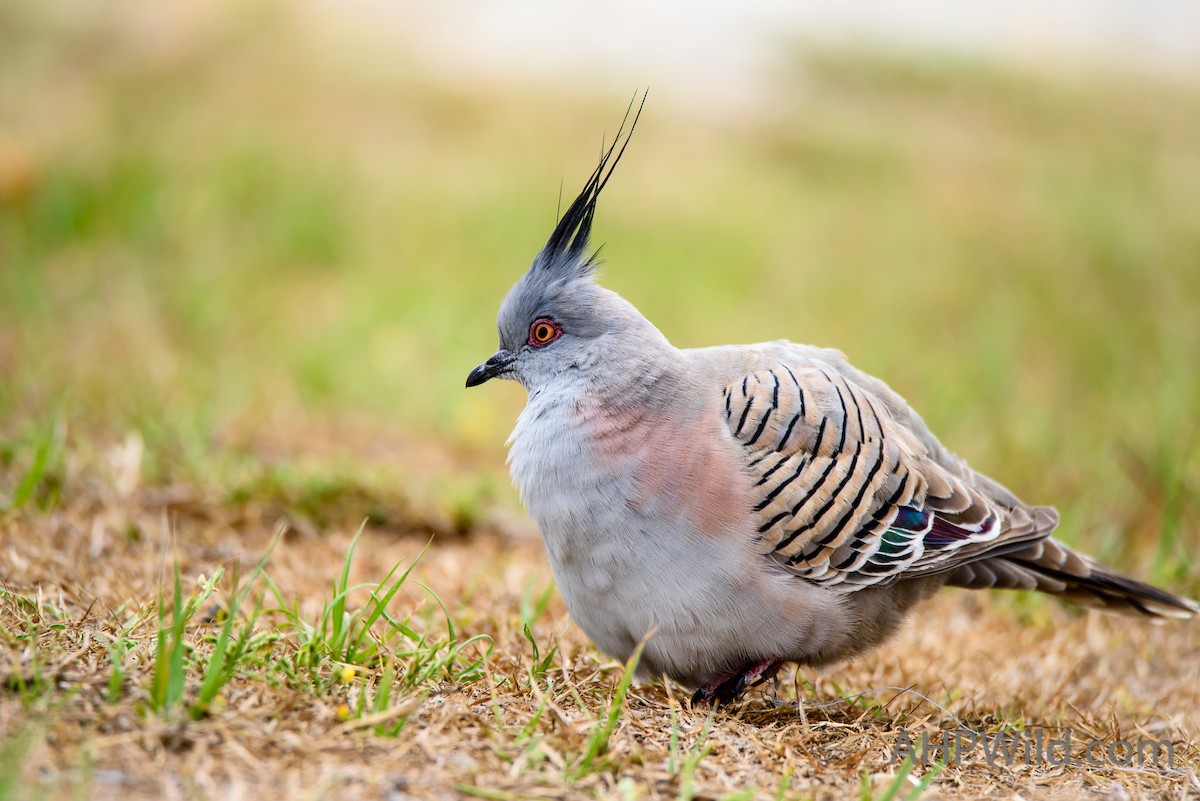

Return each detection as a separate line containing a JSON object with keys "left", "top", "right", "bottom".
{"left": 947, "top": 537, "right": 1200, "bottom": 619}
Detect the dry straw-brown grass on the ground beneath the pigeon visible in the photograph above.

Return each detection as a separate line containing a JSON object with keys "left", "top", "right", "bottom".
{"left": 0, "top": 438, "right": 1200, "bottom": 799}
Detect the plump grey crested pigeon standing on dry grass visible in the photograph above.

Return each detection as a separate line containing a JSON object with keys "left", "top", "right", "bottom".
{"left": 467, "top": 97, "right": 1200, "bottom": 704}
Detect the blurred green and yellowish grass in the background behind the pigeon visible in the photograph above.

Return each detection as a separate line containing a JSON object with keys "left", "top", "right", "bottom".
{"left": 0, "top": 5, "right": 1200, "bottom": 589}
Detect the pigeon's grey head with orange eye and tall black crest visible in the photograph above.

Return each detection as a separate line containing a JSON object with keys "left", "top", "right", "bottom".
{"left": 467, "top": 95, "right": 670, "bottom": 390}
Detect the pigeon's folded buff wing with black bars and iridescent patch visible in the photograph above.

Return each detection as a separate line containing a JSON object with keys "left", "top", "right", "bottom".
{"left": 725, "top": 363, "right": 1037, "bottom": 590}
